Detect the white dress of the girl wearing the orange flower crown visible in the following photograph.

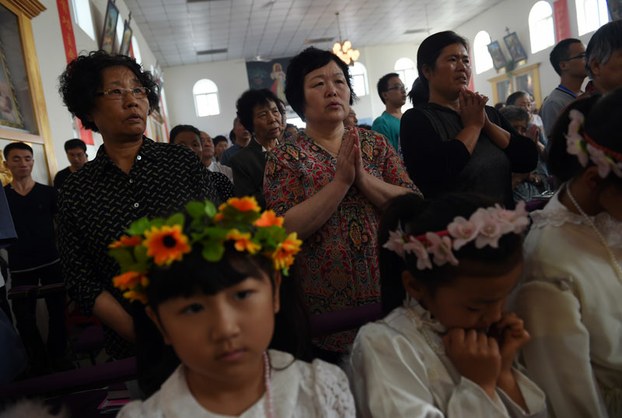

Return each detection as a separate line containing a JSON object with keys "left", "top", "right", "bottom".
{"left": 118, "top": 350, "right": 355, "bottom": 418}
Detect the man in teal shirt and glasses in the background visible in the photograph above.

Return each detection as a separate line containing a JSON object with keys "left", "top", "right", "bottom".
{"left": 371, "top": 73, "right": 406, "bottom": 151}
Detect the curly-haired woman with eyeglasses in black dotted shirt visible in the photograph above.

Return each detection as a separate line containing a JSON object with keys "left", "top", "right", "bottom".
{"left": 59, "top": 51, "right": 217, "bottom": 367}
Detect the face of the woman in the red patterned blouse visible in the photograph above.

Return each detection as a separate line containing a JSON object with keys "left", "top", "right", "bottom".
{"left": 303, "top": 61, "right": 350, "bottom": 125}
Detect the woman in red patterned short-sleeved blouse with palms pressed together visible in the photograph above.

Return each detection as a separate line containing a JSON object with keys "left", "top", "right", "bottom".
{"left": 264, "top": 48, "right": 418, "bottom": 359}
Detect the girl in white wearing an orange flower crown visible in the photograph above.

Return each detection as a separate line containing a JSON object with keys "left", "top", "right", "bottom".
{"left": 110, "top": 197, "right": 354, "bottom": 418}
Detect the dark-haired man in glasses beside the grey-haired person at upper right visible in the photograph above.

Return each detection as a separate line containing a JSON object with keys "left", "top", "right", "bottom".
{"left": 540, "top": 38, "right": 587, "bottom": 138}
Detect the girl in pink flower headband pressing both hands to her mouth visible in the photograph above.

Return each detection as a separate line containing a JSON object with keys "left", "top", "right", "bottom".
{"left": 350, "top": 194, "right": 546, "bottom": 417}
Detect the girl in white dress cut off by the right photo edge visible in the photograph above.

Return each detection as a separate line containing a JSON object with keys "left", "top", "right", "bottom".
{"left": 514, "top": 89, "right": 622, "bottom": 418}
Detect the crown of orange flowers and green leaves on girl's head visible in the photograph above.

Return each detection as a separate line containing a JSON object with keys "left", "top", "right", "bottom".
{"left": 108, "top": 197, "right": 302, "bottom": 304}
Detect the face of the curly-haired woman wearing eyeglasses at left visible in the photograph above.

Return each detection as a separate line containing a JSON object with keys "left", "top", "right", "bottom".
{"left": 89, "top": 66, "right": 149, "bottom": 142}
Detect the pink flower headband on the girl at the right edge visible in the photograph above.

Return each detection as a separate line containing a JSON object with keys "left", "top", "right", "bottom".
{"left": 566, "top": 109, "right": 622, "bottom": 178}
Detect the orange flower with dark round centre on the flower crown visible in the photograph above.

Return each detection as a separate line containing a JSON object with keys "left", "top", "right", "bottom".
{"left": 144, "top": 225, "right": 191, "bottom": 266}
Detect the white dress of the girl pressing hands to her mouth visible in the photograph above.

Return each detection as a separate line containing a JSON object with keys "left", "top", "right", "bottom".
{"left": 350, "top": 302, "right": 546, "bottom": 418}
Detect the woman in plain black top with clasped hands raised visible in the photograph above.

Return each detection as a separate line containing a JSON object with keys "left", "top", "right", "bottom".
{"left": 400, "top": 31, "right": 538, "bottom": 207}
